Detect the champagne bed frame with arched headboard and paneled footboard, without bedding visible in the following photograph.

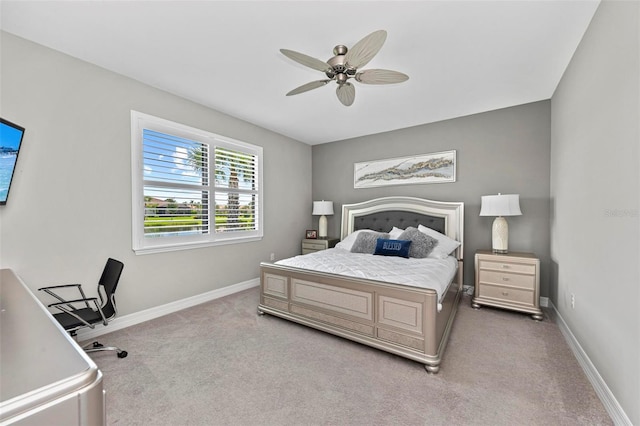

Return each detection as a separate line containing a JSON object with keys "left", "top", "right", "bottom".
{"left": 258, "top": 197, "right": 464, "bottom": 373}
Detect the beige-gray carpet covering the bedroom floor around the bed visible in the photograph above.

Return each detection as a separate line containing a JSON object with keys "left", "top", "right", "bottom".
{"left": 92, "top": 288, "right": 612, "bottom": 426}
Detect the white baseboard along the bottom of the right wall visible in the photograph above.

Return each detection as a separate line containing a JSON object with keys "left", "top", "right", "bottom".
{"left": 548, "top": 301, "right": 633, "bottom": 426}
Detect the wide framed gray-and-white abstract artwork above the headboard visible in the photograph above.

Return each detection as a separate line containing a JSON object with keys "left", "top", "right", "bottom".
{"left": 353, "top": 150, "right": 456, "bottom": 189}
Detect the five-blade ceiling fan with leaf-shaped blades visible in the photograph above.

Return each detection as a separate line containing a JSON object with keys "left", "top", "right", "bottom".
{"left": 280, "top": 30, "right": 409, "bottom": 106}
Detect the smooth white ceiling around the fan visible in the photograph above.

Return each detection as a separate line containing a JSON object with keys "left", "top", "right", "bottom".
{"left": 0, "top": 0, "right": 599, "bottom": 145}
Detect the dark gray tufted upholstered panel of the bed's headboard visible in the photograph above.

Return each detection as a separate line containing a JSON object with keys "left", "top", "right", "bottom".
{"left": 353, "top": 210, "right": 445, "bottom": 234}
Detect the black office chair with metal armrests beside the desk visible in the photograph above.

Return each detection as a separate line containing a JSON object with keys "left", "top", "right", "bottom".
{"left": 38, "top": 258, "right": 127, "bottom": 358}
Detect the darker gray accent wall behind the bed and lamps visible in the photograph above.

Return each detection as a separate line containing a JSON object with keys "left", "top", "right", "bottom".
{"left": 313, "top": 101, "right": 550, "bottom": 296}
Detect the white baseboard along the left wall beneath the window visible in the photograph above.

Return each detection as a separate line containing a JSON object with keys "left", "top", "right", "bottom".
{"left": 77, "top": 278, "right": 260, "bottom": 342}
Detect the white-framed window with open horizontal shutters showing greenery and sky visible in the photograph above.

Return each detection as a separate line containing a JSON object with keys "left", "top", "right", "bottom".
{"left": 131, "top": 111, "right": 263, "bottom": 254}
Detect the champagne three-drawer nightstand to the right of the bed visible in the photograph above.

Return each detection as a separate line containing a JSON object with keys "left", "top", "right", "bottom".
{"left": 471, "top": 250, "right": 542, "bottom": 321}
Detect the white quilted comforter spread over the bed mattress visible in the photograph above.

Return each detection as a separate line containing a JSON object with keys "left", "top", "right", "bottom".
{"left": 276, "top": 248, "right": 458, "bottom": 310}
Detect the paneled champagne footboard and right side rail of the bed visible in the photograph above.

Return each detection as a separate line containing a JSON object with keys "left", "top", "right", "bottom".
{"left": 258, "top": 262, "right": 462, "bottom": 373}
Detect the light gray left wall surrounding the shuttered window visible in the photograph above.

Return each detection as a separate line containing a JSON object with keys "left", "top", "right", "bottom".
{"left": 0, "top": 32, "right": 312, "bottom": 314}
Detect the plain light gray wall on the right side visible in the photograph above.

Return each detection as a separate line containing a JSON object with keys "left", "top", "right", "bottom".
{"left": 550, "top": 1, "right": 640, "bottom": 425}
